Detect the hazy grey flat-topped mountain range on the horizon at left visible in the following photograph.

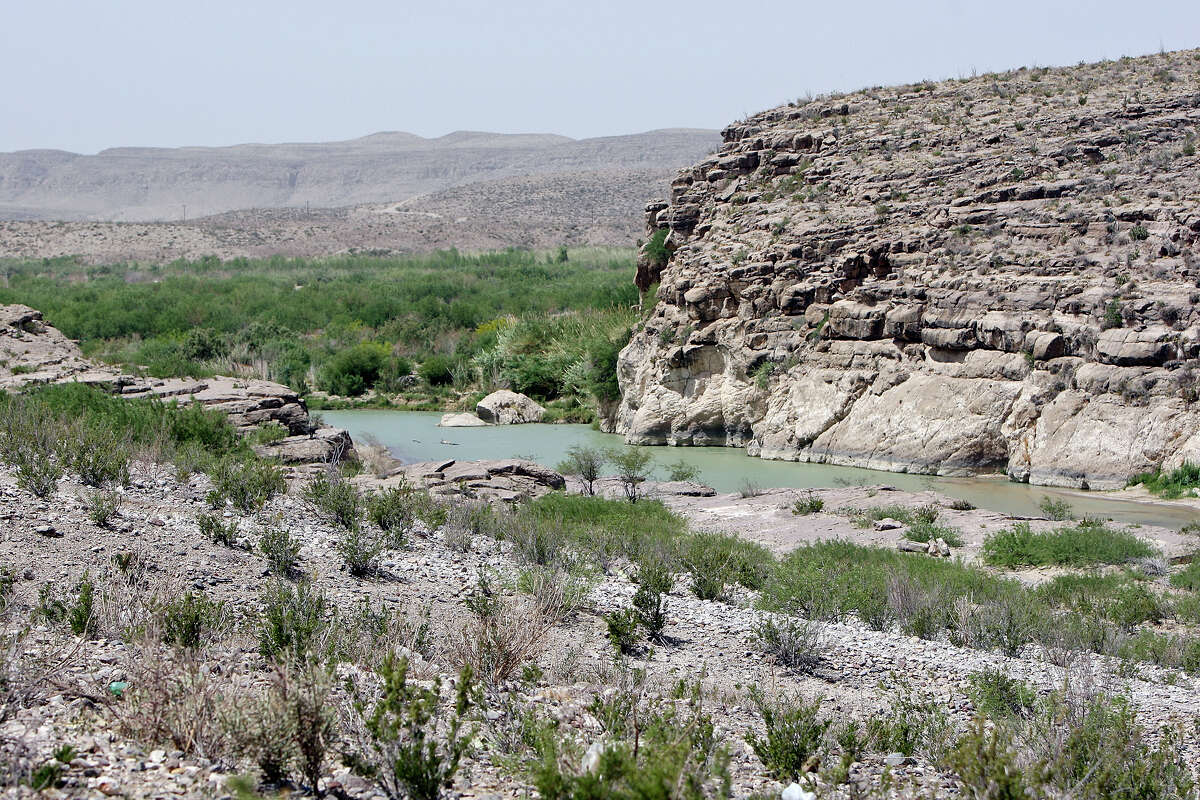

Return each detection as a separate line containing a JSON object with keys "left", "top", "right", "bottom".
{"left": 0, "top": 128, "right": 720, "bottom": 221}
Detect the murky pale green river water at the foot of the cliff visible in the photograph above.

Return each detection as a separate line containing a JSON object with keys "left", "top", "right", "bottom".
{"left": 320, "top": 410, "right": 1200, "bottom": 529}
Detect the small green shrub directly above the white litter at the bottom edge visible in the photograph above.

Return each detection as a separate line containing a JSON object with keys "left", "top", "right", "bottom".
{"left": 746, "top": 688, "right": 829, "bottom": 782}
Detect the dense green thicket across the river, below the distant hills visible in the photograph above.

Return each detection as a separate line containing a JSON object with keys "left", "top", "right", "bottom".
{"left": 0, "top": 249, "right": 638, "bottom": 412}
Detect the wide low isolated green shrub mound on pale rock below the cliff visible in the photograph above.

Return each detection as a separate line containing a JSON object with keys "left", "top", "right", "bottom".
{"left": 983, "top": 521, "right": 1157, "bottom": 567}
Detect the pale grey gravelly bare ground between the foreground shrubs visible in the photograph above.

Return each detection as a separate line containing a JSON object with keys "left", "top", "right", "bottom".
{"left": 0, "top": 464, "right": 1200, "bottom": 798}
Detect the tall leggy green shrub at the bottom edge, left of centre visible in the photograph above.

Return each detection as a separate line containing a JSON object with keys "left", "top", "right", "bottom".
{"left": 346, "top": 654, "right": 482, "bottom": 800}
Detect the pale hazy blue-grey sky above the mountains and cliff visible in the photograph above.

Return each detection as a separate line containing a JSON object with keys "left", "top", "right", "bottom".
{"left": 0, "top": 0, "right": 1200, "bottom": 152}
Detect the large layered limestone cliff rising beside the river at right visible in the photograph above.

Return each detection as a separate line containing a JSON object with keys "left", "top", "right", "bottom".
{"left": 616, "top": 50, "right": 1200, "bottom": 488}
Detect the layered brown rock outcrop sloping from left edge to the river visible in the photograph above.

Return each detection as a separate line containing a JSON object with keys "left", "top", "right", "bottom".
{"left": 0, "top": 306, "right": 353, "bottom": 463}
